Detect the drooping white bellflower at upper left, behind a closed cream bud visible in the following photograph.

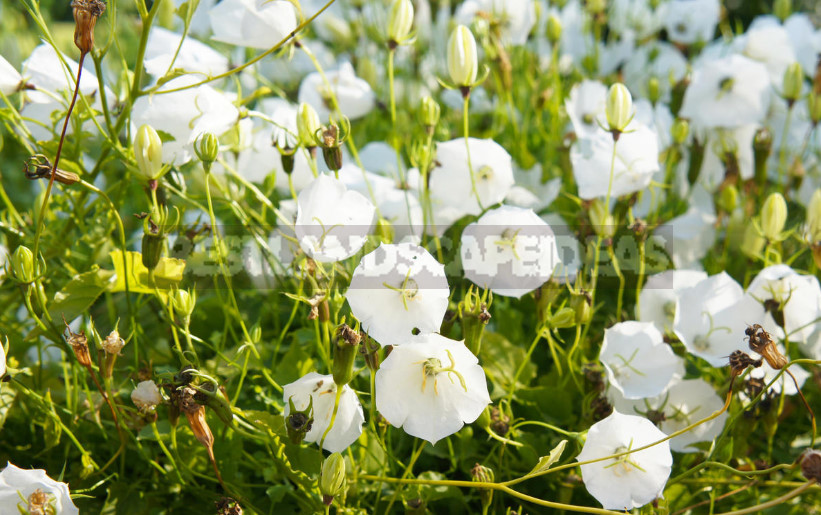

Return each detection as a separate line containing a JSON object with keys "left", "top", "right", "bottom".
{"left": 131, "top": 75, "right": 239, "bottom": 165}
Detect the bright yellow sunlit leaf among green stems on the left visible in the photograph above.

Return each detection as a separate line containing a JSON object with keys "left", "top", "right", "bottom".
{"left": 109, "top": 250, "right": 185, "bottom": 301}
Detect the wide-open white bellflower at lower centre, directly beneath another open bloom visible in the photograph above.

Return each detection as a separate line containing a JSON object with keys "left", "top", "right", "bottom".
{"left": 376, "top": 334, "right": 490, "bottom": 444}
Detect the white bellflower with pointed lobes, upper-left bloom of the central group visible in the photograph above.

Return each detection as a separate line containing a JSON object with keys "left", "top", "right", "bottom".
{"left": 295, "top": 174, "right": 375, "bottom": 263}
